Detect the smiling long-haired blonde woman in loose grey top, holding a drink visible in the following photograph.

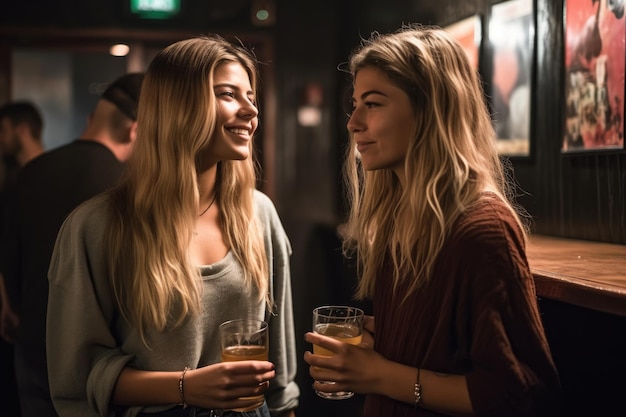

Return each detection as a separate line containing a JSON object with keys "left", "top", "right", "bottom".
{"left": 47, "top": 35, "right": 299, "bottom": 417}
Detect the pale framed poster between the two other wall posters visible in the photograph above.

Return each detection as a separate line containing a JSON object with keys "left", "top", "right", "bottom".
{"left": 489, "top": 0, "right": 535, "bottom": 156}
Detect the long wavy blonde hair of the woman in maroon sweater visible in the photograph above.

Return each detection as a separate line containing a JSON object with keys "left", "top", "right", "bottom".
{"left": 343, "top": 25, "right": 526, "bottom": 299}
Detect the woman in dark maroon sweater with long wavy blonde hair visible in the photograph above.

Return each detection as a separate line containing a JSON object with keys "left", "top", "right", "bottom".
{"left": 304, "top": 25, "right": 560, "bottom": 417}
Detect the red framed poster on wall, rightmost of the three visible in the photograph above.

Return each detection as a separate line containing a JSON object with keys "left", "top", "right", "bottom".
{"left": 562, "top": 0, "right": 626, "bottom": 152}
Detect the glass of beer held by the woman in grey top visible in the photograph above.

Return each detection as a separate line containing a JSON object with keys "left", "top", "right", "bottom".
{"left": 219, "top": 319, "right": 269, "bottom": 412}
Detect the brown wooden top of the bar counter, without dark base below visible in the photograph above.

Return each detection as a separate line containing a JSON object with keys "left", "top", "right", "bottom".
{"left": 526, "top": 235, "right": 626, "bottom": 317}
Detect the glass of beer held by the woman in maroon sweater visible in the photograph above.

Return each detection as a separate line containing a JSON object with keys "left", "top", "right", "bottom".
{"left": 313, "top": 306, "right": 363, "bottom": 400}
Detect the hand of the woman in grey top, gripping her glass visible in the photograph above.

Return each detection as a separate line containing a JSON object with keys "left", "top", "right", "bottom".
{"left": 184, "top": 361, "right": 276, "bottom": 410}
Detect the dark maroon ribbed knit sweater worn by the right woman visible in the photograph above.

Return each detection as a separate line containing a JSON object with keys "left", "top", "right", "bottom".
{"left": 365, "top": 194, "right": 559, "bottom": 417}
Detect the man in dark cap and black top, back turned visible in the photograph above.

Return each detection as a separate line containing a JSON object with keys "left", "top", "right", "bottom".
{"left": 0, "top": 73, "right": 143, "bottom": 417}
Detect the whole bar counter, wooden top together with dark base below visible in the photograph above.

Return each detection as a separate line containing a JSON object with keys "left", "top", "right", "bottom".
{"left": 526, "top": 232, "right": 626, "bottom": 417}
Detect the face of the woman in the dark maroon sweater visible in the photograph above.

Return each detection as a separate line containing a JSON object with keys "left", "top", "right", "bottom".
{"left": 348, "top": 67, "right": 416, "bottom": 181}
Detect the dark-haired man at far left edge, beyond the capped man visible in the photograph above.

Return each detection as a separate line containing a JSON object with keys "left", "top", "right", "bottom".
{"left": 0, "top": 100, "right": 44, "bottom": 417}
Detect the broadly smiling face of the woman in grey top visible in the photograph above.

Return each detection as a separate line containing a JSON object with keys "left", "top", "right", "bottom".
{"left": 206, "top": 62, "right": 259, "bottom": 162}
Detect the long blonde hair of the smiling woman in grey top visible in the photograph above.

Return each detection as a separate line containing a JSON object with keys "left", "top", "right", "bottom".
{"left": 107, "top": 35, "right": 269, "bottom": 341}
